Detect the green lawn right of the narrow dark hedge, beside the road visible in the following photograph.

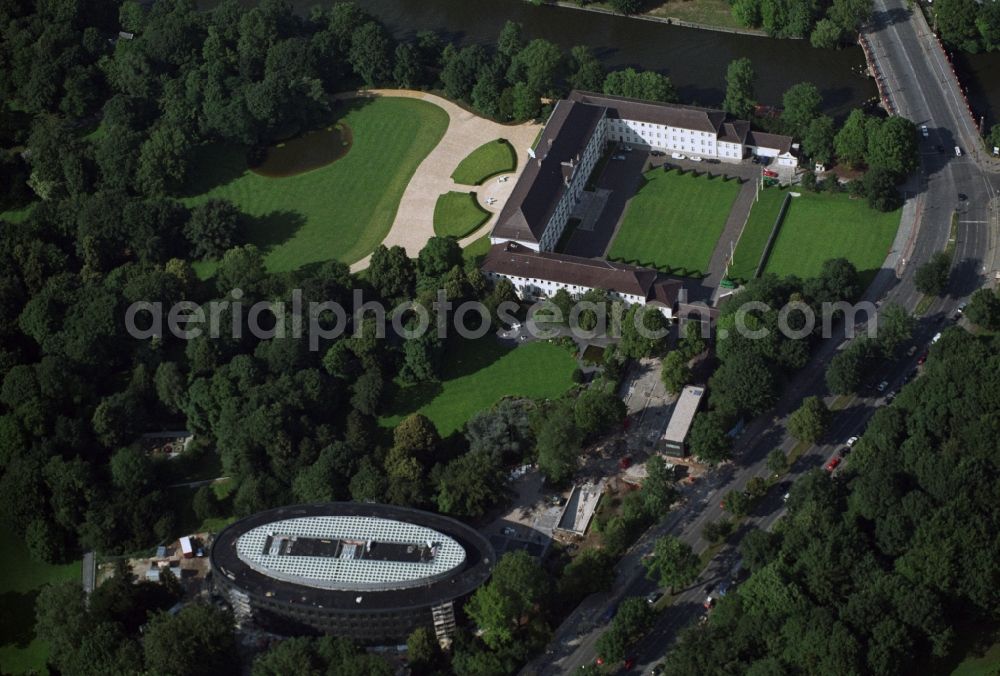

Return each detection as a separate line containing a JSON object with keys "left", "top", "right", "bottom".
{"left": 765, "top": 192, "right": 900, "bottom": 283}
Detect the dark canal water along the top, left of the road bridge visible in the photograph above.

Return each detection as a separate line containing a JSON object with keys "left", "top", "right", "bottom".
{"left": 348, "top": 0, "right": 877, "bottom": 116}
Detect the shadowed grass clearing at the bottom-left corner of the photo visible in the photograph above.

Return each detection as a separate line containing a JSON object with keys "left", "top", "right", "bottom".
{"left": 0, "top": 527, "right": 81, "bottom": 674}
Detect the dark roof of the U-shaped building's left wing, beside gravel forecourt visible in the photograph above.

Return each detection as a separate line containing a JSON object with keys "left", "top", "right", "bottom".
{"left": 493, "top": 100, "right": 605, "bottom": 242}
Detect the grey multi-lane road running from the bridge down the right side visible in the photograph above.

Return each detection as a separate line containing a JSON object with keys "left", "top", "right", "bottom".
{"left": 525, "top": 0, "right": 1000, "bottom": 674}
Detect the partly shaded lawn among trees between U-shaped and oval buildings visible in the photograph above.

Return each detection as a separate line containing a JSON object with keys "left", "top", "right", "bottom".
{"left": 381, "top": 334, "right": 576, "bottom": 436}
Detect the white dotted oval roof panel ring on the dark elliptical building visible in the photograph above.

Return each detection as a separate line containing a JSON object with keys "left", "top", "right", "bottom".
{"left": 236, "top": 516, "right": 465, "bottom": 591}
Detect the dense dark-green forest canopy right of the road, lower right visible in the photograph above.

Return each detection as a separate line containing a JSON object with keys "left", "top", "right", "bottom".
{"left": 665, "top": 329, "right": 1000, "bottom": 675}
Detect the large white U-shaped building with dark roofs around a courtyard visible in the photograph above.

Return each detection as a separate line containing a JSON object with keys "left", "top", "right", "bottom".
{"left": 482, "top": 91, "right": 797, "bottom": 317}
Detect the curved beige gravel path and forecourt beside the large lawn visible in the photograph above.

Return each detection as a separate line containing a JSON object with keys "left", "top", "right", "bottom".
{"left": 335, "top": 89, "right": 541, "bottom": 272}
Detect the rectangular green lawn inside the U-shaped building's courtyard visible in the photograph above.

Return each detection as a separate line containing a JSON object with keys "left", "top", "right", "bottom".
{"left": 609, "top": 169, "right": 740, "bottom": 277}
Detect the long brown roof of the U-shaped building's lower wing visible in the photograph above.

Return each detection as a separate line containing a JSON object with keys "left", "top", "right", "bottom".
{"left": 482, "top": 242, "right": 682, "bottom": 307}
